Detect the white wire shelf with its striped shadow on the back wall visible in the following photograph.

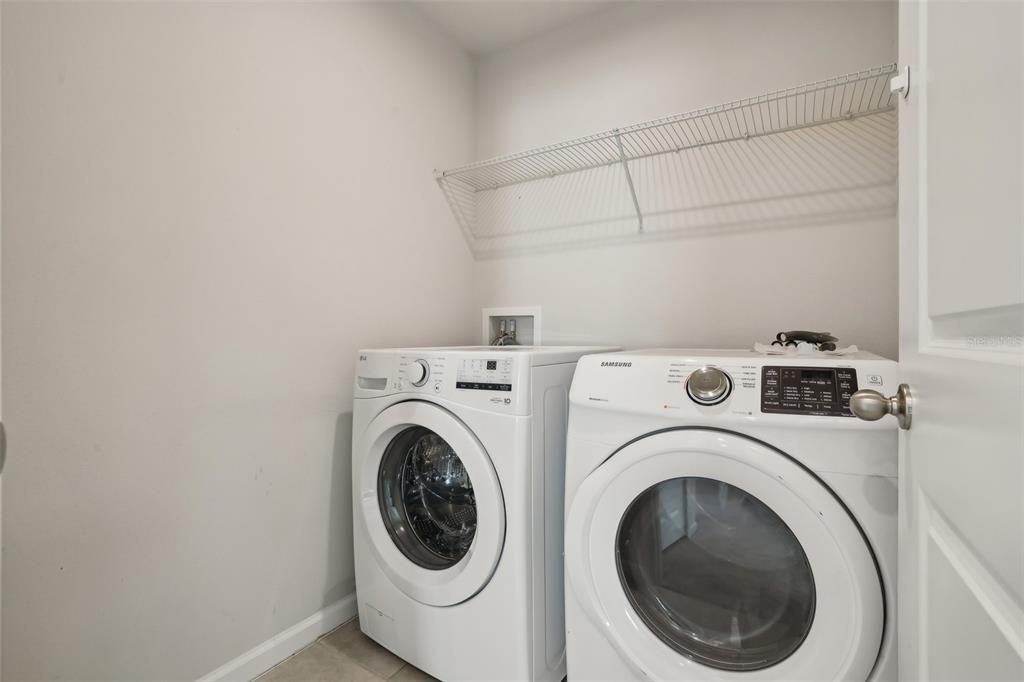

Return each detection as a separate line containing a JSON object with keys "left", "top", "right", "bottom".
{"left": 436, "top": 65, "right": 897, "bottom": 255}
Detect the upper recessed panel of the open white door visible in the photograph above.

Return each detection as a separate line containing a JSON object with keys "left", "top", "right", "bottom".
{"left": 929, "top": 1, "right": 1024, "bottom": 316}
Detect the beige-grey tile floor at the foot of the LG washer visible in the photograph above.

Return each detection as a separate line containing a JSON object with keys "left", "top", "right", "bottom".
{"left": 256, "top": 619, "right": 436, "bottom": 682}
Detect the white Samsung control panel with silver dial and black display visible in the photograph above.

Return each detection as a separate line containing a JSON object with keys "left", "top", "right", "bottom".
{"left": 569, "top": 348, "right": 899, "bottom": 431}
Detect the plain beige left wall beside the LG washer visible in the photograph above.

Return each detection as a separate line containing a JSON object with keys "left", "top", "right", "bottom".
{"left": 2, "top": 2, "right": 478, "bottom": 680}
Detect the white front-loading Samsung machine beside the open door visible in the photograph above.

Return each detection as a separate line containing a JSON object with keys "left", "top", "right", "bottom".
{"left": 565, "top": 350, "right": 899, "bottom": 682}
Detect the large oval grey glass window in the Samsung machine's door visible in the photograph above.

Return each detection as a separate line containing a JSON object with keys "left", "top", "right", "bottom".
{"left": 615, "top": 477, "right": 815, "bottom": 671}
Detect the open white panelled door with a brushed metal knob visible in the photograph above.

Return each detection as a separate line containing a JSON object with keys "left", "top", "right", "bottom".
{"left": 898, "top": 0, "right": 1024, "bottom": 681}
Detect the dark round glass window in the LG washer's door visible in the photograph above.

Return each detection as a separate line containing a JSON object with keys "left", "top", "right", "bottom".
{"left": 377, "top": 426, "right": 476, "bottom": 570}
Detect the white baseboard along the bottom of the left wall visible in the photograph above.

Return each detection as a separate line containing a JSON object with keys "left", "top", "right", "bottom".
{"left": 199, "top": 592, "right": 356, "bottom": 682}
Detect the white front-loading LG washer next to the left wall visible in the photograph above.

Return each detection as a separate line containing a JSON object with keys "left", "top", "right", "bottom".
{"left": 352, "top": 346, "right": 608, "bottom": 681}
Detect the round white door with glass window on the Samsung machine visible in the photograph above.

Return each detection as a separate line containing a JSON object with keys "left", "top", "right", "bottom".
{"left": 565, "top": 429, "right": 885, "bottom": 680}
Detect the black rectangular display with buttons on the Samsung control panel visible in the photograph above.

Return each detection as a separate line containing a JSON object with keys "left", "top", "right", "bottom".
{"left": 761, "top": 367, "right": 857, "bottom": 417}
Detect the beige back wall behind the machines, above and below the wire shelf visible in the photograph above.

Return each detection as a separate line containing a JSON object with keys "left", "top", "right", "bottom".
{"left": 476, "top": 1, "right": 897, "bottom": 357}
